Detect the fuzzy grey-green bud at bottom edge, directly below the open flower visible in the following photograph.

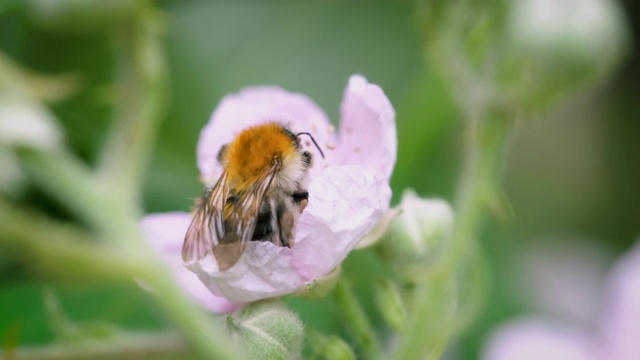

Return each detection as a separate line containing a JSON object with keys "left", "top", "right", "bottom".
{"left": 227, "top": 301, "right": 304, "bottom": 360}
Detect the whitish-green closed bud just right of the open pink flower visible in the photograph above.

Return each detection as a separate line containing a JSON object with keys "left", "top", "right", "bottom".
{"left": 378, "top": 190, "right": 453, "bottom": 280}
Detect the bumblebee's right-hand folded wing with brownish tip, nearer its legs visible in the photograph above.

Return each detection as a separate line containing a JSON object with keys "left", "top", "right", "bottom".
{"left": 213, "top": 159, "right": 281, "bottom": 271}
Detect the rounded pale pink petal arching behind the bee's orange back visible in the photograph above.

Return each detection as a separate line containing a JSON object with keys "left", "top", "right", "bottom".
{"left": 197, "top": 86, "right": 336, "bottom": 185}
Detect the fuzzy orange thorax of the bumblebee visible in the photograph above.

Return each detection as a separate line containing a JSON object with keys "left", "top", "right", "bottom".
{"left": 225, "top": 123, "right": 296, "bottom": 188}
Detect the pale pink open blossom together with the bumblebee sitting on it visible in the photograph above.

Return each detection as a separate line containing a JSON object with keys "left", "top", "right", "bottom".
{"left": 142, "top": 75, "right": 397, "bottom": 311}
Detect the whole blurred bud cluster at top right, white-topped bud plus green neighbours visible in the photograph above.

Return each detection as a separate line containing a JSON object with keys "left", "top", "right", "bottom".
{"left": 417, "top": 0, "right": 630, "bottom": 118}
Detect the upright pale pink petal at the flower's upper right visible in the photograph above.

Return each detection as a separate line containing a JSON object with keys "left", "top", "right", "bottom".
{"left": 336, "top": 75, "right": 398, "bottom": 179}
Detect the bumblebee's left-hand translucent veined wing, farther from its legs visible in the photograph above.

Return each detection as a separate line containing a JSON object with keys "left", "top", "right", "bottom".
{"left": 182, "top": 171, "right": 229, "bottom": 262}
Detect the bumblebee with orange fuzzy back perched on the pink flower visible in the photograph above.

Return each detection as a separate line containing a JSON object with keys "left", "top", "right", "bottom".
{"left": 182, "top": 122, "right": 324, "bottom": 271}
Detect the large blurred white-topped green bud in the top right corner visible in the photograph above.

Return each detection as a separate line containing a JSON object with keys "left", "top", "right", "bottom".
{"left": 498, "top": 0, "right": 628, "bottom": 110}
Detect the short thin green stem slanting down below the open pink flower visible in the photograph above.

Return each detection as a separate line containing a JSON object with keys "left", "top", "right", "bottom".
{"left": 334, "top": 277, "right": 382, "bottom": 360}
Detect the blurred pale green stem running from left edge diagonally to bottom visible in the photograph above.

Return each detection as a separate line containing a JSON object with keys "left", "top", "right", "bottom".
{"left": 0, "top": 202, "right": 241, "bottom": 359}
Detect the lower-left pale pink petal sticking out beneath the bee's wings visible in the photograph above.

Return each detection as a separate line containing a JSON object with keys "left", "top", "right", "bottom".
{"left": 141, "top": 212, "right": 240, "bottom": 313}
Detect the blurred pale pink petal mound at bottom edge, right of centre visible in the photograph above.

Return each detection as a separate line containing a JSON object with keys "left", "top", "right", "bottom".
{"left": 482, "top": 319, "right": 598, "bottom": 360}
